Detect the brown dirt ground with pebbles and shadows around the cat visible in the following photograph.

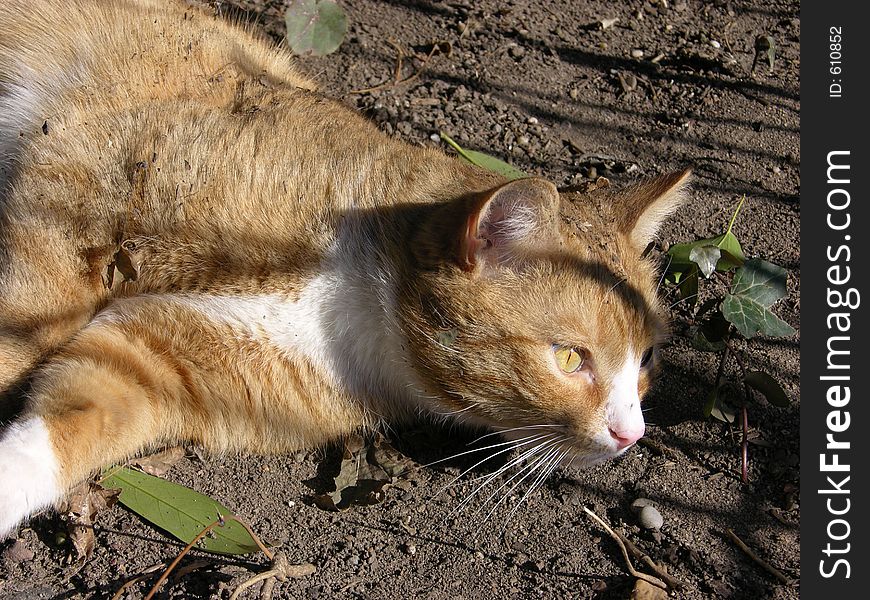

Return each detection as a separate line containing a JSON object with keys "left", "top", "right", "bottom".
{"left": 0, "top": 0, "right": 800, "bottom": 600}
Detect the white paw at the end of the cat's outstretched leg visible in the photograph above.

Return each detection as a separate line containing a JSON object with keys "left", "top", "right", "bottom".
{"left": 0, "top": 417, "right": 61, "bottom": 540}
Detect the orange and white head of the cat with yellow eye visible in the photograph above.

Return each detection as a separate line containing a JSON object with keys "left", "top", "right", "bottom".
{"left": 400, "top": 171, "right": 689, "bottom": 465}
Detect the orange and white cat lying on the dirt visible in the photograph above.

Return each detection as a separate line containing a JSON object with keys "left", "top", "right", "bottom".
{"left": 0, "top": 0, "right": 690, "bottom": 538}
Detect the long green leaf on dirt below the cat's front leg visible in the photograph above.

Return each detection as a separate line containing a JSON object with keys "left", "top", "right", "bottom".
{"left": 101, "top": 467, "right": 260, "bottom": 554}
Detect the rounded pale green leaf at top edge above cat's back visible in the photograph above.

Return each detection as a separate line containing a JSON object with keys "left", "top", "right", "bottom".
{"left": 284, "top": 0, "right": 347, "bottom": 56}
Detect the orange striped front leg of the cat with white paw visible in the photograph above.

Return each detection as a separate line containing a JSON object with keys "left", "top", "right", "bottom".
{"left": 0, "top": 295, "right": 366, "bottom": 538}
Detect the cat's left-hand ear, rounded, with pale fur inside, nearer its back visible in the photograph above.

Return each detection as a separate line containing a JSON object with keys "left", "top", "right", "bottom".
{"left": 458, "top": 177, "right": 559, "bottom": 271}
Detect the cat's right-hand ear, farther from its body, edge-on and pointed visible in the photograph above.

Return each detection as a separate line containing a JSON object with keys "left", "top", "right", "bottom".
{"left": 614, "top": 169, "right": 692, "bottom": 254}
